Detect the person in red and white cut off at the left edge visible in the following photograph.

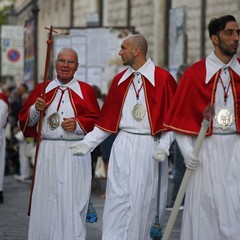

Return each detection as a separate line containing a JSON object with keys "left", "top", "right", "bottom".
{"left": 0, "top": 85, "right": 9, "bottom": 203}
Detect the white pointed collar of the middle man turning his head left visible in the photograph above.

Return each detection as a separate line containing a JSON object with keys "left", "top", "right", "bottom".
{"left": 118, "top": 58, "right": 155, "bottom": 86}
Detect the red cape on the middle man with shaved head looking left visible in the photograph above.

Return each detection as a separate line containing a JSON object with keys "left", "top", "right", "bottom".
{"left": 96, "top": 67, "right": 177, "bottom": 135}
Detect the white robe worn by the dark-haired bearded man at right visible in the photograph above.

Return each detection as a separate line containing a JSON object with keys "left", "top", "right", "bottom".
{"left": 176, "top": 54, "right": 240, "bottom": 240}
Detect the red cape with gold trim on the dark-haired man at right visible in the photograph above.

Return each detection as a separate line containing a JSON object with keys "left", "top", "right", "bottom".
{"left": 164, "top": 59, "right": 240, "bottom": 136}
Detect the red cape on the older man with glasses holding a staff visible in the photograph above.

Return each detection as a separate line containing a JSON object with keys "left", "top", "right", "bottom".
{"left": 18, "top": 81, "right": 99, "bottom": 137}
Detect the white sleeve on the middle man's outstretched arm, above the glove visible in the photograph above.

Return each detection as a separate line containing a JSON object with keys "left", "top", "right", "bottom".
{"left": 82, "top": 127, "right": 111, "bottom": 151}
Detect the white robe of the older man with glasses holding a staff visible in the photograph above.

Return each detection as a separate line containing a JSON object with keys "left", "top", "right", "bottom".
{"left": 28, "top": 82, "right": 91, "bottom": 240}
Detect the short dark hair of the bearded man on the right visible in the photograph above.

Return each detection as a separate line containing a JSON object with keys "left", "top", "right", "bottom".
{"left": 208, "top": 15, "right": 236, "bottom": 37}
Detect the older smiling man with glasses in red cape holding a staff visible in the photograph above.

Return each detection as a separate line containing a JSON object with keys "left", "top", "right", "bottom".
{"left": 19, "top": 48, "right": 99, "bottom": 240}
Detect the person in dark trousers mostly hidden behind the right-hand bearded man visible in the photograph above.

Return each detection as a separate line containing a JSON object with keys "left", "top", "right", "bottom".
{"left": 167, "top": 64, "right": 189, "bottom": 210}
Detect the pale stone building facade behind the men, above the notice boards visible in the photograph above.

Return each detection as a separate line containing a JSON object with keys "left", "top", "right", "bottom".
{"left": 9, "top": 0, "right": 240, "bottom": 85}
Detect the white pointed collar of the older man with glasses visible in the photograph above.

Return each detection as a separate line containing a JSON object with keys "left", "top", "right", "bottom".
{"left": 46, "top": 78, "right": 83, "bottom": 99}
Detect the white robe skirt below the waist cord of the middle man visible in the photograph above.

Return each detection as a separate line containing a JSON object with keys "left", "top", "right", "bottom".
{"left": 102, "top": 131, "right": 168, "bottom": 240}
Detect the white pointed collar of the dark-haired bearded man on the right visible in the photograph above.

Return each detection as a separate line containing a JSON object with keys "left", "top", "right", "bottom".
{"left": 205, "top": 52, "right": 240, "bottom": 84}
